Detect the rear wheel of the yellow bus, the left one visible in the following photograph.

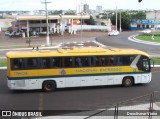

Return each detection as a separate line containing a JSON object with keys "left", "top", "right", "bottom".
{"left": 42, "top": 81, "right": 56, "bottom": 92}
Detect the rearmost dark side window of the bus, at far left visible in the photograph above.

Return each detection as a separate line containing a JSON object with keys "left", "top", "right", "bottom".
{"left": 11, "top": 58, "right": 24, "bottom": 70}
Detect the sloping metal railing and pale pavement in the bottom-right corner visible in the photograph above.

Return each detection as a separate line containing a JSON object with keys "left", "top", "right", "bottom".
{"left": 84, "top": 91, "right": 160, "bottom": 119}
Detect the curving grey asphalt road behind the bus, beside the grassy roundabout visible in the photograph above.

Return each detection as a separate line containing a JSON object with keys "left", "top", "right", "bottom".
{"left": 97, "top": 31, "right": 160, "bottom": 55}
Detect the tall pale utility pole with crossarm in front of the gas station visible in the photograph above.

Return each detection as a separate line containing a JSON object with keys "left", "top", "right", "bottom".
{"left": 41, "top": 0, "right": 51, "bottom": 46}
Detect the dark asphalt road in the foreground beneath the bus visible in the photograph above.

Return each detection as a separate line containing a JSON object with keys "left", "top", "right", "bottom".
{"left": 0, "top": 70, "right": 160, "bottom": 110}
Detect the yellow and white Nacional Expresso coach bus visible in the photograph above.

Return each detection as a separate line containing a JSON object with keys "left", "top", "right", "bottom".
{"left": 6, "top": 47, "right": 151, "bottom": 91}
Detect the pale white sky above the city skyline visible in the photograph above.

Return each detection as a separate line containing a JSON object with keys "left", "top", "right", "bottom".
{"left": 0, "top": 0, "right": 160, "bottom": 11}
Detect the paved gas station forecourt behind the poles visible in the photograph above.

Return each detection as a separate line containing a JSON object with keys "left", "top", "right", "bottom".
{"left": 0, "top": 31, "right": 106, "bottom": 48}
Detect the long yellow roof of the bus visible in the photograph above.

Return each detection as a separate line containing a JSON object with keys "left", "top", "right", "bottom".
{"left": 6, "top": 47, "right": 149, "bottom": 58}
